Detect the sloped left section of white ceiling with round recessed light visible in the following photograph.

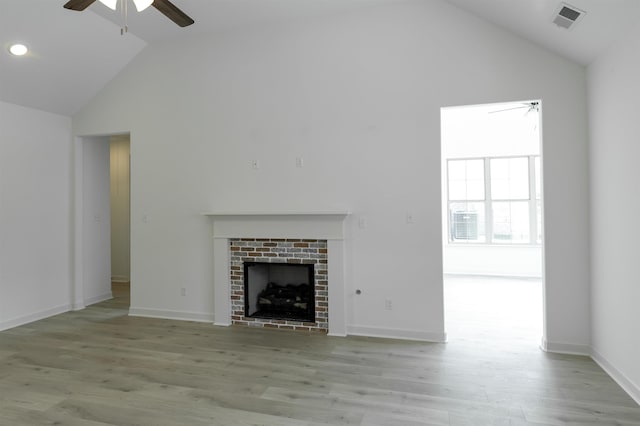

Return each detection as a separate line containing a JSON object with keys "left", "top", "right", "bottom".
{"left": 0, "top": 0, "right": 146, "bottom": 115}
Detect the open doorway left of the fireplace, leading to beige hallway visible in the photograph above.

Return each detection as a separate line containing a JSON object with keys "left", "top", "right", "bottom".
{"left": 74, "top": 134, "right": 130, "bottom": 309}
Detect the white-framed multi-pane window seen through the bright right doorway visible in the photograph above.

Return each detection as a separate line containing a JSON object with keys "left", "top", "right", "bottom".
{"left": 447, "top": 156, "right": 542, "bottom": 244}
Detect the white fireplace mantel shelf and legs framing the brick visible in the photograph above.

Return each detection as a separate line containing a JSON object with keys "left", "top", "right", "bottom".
{"left": 203, "top": 210, "right": 350, "bottom": 336}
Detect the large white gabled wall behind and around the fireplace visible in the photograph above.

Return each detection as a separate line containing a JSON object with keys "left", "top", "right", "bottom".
{"left": 74, "top": 0, "right": 589, "bottom": 348}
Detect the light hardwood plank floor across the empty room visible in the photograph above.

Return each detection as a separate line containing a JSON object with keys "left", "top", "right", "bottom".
{"left": 0, "top": 280, "right": 640, "bottom": 426}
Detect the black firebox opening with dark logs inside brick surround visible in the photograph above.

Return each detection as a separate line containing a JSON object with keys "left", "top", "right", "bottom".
{"left": 244, "top": 262, "right": 315, "bottom": 322}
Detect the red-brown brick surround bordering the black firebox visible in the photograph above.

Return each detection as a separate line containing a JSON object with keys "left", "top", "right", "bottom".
{"left": 229, "top": 238, "right": 329, "bottom": 333}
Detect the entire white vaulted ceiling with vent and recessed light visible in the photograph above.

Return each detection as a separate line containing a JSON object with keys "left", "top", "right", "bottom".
{"left": 0, "top": 0, "right": 640, "bottom": 115}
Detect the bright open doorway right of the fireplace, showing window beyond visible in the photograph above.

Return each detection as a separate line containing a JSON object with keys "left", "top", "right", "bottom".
{"left": 441, "top": 100, "right": 544, "bottom": 348}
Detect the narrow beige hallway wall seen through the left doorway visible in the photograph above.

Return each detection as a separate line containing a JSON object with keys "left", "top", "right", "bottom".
{"left": 109, "top": 135, "right": 131, "bottom": 282}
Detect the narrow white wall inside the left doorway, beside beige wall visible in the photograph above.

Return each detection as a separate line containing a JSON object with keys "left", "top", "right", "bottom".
{"left": 82, "top": 137, "right": 112, "bottom": 305}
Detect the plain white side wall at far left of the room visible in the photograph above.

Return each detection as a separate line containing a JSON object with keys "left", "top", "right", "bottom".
{"left": 0, "top": 102, "right": 72, "bottom": 330}
